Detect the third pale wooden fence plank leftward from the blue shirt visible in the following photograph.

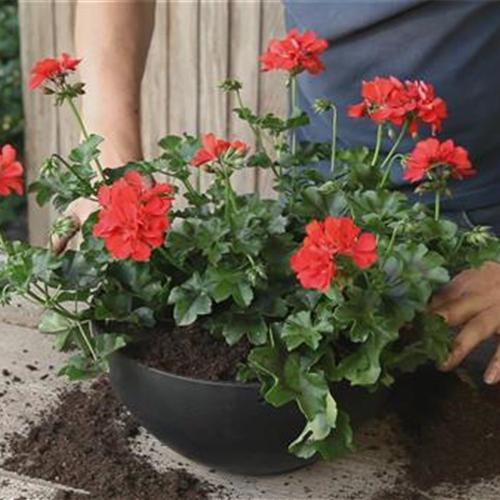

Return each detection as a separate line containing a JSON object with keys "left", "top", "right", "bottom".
{"left": 199, "top": 0, "right": 230, "bottom": 190}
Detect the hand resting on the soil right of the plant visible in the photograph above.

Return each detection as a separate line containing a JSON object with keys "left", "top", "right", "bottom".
{"left": 429, "top": 262, "right": 500, "bottom": 384}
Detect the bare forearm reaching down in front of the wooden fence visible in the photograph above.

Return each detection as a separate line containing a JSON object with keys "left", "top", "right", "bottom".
{"left": 76, "top": 0, "right": 155, "bottom": 167}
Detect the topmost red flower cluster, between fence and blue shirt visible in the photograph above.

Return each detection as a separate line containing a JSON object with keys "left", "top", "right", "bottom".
{"left": 260, "top": 28, "right": 328, "bottom": 75}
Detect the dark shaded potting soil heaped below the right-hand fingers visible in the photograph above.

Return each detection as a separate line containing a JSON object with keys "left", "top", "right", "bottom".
{"left": 384, "top": 368, "right": 500, "bottom": 494}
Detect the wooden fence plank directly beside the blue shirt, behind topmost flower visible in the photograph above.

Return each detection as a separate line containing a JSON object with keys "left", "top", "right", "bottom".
{"left": 258, "top": 0, "right": 287, "bottom": 197}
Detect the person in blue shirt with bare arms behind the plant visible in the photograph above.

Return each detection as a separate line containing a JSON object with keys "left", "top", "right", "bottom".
{"left": 64, "top": 0, "right": 500, "bottom": 384}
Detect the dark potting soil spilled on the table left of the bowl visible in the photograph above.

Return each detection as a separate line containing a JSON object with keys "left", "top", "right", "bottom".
{"left": 2, "top": 380, "right": 219, "bottom": 500}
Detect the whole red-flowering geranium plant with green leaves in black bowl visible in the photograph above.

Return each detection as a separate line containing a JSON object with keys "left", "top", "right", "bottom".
{"left": 0, "top": 30, "right": 499, "bottom": 459}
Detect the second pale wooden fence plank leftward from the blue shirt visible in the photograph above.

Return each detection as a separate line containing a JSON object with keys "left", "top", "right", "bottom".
{"left": 228, "top": 0, "right": 262, "bottom": 193}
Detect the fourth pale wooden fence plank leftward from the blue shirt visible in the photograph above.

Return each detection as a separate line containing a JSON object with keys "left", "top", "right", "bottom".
{"left": 165, "top": 0, "right": 200, "bottom": 208}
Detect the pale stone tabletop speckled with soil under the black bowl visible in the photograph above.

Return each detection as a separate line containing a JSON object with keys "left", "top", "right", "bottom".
{"left": 0, "top": 302, "right": 500, "bottom": 500}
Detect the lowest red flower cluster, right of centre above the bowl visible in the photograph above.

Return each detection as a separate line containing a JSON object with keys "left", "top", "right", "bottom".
{"left": 290, "top": 217, "right": 377, "bottom": 292}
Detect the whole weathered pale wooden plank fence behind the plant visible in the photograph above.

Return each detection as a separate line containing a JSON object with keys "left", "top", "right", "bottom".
{"left": 20, "top": 0, "right": 286, "bottom": 244}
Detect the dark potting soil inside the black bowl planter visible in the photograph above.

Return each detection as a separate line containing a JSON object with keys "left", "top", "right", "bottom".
{"left": 131, "top": 325, "right": 251, "bottom": 380}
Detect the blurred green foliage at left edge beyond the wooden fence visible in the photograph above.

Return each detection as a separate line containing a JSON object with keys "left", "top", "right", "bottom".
{"left": 0, "top": 0, "right": 25, "bottom": 232}
